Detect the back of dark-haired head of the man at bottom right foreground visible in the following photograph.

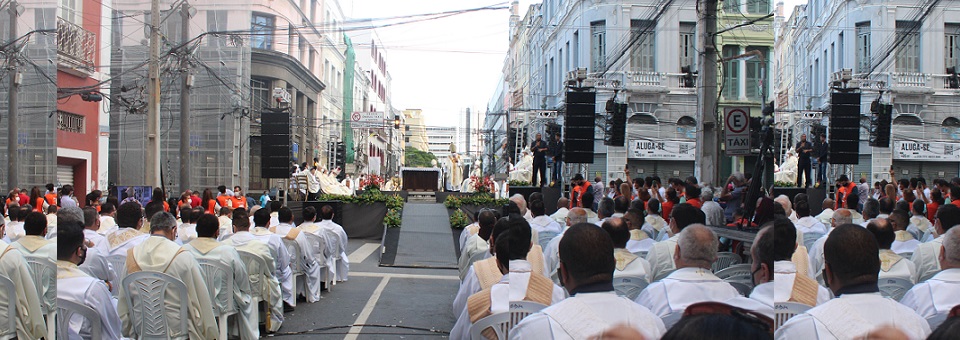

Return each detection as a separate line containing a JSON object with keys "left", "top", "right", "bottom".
{"left": 823, "top": 224, "right": 880, "bottom": 293}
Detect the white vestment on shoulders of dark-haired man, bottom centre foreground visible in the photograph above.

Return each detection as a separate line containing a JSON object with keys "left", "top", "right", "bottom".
{"left": 510, "top": 291, "right": 666, "bottom": 340}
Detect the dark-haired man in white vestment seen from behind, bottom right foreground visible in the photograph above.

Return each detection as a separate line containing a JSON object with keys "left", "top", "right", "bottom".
{"left": 776, "top": 224, "right": 930, "bottom": 339}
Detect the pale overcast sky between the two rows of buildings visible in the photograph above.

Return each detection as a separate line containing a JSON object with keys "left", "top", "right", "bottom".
{"left": 341, "top": 0, "right": 533, "bottom": 126}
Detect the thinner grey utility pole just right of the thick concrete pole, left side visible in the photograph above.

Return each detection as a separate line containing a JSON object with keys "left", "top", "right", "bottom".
{"left": 180, "top": 1, "right": 193, "bottom": 192}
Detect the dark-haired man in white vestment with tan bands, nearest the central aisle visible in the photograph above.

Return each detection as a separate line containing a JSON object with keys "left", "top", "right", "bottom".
{"left": 450, "top": 219, "right": 566, "bottom": 339}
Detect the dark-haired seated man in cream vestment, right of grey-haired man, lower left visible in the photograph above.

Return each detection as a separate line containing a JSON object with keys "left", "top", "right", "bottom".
{"left": 183, "top": 214, "right": 260, "bottom": 340}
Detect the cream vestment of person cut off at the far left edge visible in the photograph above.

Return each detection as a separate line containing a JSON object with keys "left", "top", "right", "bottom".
{"left": 0, "top": 241, "right": 47, "bottom": 339}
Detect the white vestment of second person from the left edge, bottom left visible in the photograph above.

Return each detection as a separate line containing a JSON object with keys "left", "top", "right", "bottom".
{"left": 57, "top": 261, "right": 123, "bottom": 339}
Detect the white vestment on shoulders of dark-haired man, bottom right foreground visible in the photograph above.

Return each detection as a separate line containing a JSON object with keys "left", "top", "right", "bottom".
{"left": 775, "top": 293, "right": 930, "bottom": 340}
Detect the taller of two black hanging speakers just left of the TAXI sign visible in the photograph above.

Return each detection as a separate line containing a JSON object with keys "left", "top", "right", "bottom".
{"left": 563, "top": 91, "right": 597, "bottom": 164}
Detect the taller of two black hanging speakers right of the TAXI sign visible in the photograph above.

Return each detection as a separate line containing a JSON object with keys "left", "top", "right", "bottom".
{"left": 829, "top": 92, "right": 860, "bottom": 164}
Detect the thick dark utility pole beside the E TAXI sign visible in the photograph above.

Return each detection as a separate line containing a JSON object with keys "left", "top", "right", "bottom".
{"left": 695, "top": 0, "right": 722, "bottom": 185}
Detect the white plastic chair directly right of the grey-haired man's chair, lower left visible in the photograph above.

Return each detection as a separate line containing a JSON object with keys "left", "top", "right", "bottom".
{"left": 197, "top": 258, "right": 237, "bottom": 340}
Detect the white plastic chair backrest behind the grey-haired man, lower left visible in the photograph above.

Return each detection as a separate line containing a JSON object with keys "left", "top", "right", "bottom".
{"left": 123, "top": 271, "right": 190, "bottom": 339}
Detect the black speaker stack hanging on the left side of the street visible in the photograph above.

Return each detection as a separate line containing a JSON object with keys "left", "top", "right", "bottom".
{"left": 260, "top": 108, "right": 290, "bottom": 178}
